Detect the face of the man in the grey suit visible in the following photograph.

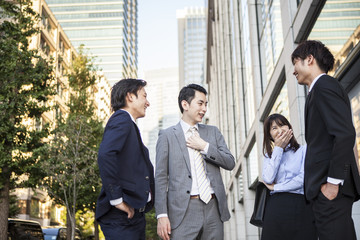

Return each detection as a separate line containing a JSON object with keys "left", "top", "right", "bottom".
{"left": 183, "top": 91, "right": 207, "bottom": 125}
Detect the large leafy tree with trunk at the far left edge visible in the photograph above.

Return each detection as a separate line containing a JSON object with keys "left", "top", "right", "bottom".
{"left": 0, "top": 0, "right": 55, "bottom": 240}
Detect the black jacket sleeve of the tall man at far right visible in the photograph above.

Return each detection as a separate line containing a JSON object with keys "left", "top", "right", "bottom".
{"left": 314, "top": 84, "right": 355, "bottom": 180}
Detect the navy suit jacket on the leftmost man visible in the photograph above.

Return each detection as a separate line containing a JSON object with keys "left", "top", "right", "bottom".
{"left": 96, "top": 110, "right": 155, "bottom": 219}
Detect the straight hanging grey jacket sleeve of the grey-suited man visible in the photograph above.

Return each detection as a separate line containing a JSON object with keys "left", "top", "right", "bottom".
{"left": 155, "top": 130, "right": 169, "bottom": 216}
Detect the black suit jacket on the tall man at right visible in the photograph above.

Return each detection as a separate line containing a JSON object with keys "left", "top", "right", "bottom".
{"left": 304, "top": 75, "right": 360, "bottom": 200}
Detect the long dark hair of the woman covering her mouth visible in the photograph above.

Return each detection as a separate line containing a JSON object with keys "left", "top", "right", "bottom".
{"left": 263, "top": 113, "right": 300, "bottom": 158}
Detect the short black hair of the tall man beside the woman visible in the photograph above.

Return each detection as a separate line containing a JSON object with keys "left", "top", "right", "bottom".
{"left": 291, "top": 40, "right": 335, "bottom": 73}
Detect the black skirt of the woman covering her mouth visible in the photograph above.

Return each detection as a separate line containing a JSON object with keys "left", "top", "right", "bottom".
{"left": 261, "top": 193, "right": 317, "bottom": 240}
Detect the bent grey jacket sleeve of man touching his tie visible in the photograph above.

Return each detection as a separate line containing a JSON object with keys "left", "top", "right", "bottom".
{"left": 204, "top": 127, "right": 235, "bottom": 170}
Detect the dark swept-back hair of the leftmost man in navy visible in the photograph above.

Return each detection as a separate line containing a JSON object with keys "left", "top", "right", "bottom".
{"left": 111, "top": 78, "right": 146, "bottom": 112}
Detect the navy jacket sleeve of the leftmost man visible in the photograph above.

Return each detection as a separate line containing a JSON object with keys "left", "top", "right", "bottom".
{"left": 98, "top": 114, "right": 131, "bottom": 200}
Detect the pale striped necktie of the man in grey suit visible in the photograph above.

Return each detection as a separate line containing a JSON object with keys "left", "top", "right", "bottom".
{"left": 190, "top": 127, "right": 211, "bottom": 204}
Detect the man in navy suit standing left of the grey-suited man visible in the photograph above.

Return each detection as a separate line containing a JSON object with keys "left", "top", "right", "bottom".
{"left": 96, "top": 79, "right": 155, "bottom": 240}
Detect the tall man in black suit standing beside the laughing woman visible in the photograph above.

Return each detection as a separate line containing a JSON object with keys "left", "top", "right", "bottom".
{"left": 291, "top": 40, "right": 360, "bottom": 240}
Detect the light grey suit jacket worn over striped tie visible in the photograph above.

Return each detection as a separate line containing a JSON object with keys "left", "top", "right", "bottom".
{"left": 155, "top": 123, "right": 235, "bottom": 229}
